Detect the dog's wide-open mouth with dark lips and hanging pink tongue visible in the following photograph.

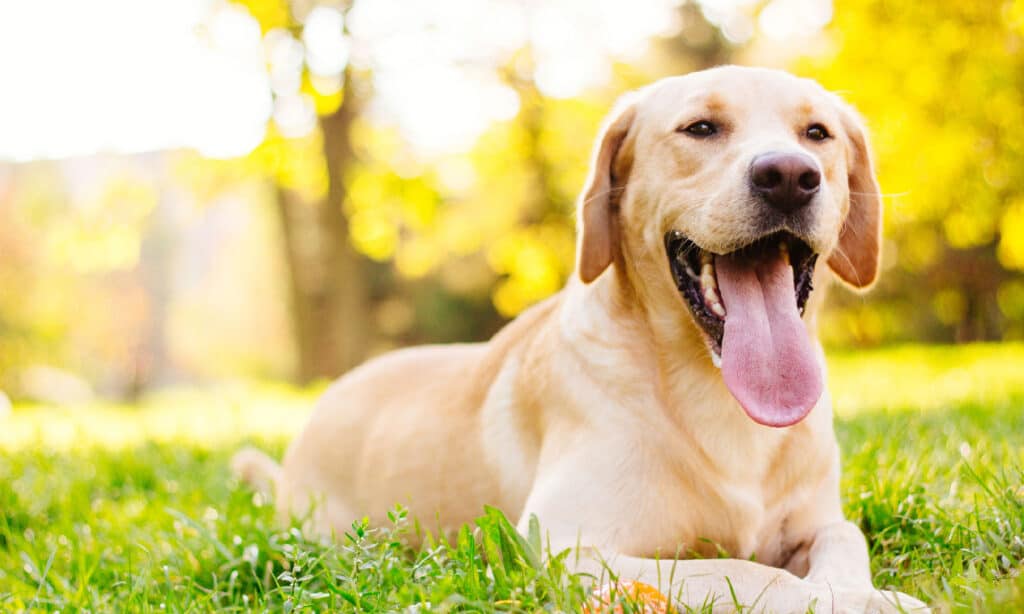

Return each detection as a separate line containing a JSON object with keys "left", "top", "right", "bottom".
{"left": 665, "top": 230, "right": 822, "bottom": 427}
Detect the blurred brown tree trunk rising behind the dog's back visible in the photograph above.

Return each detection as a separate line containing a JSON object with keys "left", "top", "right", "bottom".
{"left": 278, "top": 69, "right": 372, "bottom": 382}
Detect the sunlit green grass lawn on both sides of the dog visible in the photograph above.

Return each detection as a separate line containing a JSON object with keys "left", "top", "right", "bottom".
{"left": 0, "top": 344, "right": 1024, "bottom": 612}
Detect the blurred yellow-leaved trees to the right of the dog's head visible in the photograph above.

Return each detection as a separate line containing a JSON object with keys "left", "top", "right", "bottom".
{"left": 799, "top": 0, "right": 1024, "bottom": 343}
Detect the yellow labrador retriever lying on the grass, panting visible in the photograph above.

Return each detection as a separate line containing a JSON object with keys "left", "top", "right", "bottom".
{"left": 234, "top": 67, "right": 924, "bottom": 612}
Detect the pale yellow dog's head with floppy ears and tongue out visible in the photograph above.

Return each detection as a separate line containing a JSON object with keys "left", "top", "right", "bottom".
{"left": 578, "top": 67, "right": 882, "bottom": 426}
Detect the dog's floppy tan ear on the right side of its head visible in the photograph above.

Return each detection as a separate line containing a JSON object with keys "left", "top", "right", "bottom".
{"left": 828, "top": 103, "right": 882, "bottom": 289}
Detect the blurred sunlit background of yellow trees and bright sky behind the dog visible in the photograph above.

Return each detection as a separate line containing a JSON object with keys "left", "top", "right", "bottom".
{"left": 0, "top": 0, "right": 1024, "bottom": 405}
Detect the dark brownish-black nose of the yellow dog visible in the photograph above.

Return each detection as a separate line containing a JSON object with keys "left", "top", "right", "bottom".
{"left": 751, "top": 154, "right": 821, "bottom": 213}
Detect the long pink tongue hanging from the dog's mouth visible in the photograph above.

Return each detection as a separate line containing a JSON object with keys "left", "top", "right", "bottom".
{"left": 715, "top": 249, "right": 821, "bottom": 427}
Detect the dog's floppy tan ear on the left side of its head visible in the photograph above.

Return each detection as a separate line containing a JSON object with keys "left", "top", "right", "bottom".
{"left": 577, "top": 95, "right": 636, "bottom": 283}
